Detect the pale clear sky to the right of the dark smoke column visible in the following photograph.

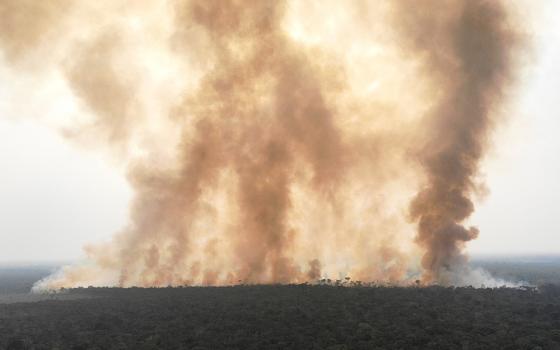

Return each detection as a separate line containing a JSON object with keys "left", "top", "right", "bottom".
{"left": 469, "top": 1, "right": 560, "bottom": 254}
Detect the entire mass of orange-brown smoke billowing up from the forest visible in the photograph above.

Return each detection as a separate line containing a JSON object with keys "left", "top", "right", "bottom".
{"left": 0, "top": 0, "right": 516, "bottom": 288}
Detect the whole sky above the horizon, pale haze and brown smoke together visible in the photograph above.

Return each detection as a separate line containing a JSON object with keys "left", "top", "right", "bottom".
{"left": 0, "top": 0, "right": 560, "bottom": 285}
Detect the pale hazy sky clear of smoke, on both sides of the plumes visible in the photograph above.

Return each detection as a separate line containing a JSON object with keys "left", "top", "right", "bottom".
{"left": 0, "top": 1, "right": 560, "bottom": 261}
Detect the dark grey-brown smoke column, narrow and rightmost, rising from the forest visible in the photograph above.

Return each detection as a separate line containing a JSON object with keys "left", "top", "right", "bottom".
{"left": 398, "top": 0, "right": 518, "bottom": 284}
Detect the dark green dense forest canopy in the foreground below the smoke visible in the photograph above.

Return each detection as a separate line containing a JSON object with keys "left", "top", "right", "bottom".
{"left": 0, "top": 285, "right": 560, "bottom": 350}
